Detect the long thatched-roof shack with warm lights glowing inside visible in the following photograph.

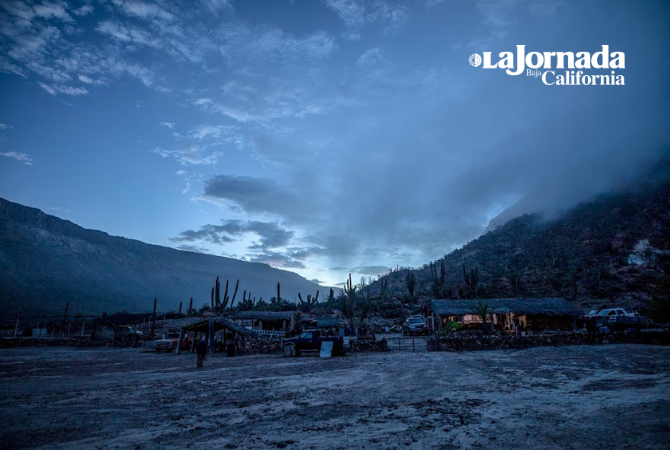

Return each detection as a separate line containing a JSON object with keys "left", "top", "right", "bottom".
{"left": 426, "top": 298, "right": 582, "bottom": 332}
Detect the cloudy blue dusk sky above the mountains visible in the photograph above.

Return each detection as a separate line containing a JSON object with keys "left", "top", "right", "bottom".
{"left": 0, "top": 0, "right": 670, "bottom": 285}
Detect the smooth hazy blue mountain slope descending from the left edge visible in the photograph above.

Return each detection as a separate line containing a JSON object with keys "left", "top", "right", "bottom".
{"left": 0, "top": 198, "right": 326, "bottom": 322}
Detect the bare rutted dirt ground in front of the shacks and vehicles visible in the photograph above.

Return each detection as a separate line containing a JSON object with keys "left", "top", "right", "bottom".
{"left": 0, "top": 345, "right": 670, "bottom": 449}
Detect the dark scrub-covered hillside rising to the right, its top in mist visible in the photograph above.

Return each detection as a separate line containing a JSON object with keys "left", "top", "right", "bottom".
{"left": 371, "top": 158, "right": 670, "bottom": 309}
